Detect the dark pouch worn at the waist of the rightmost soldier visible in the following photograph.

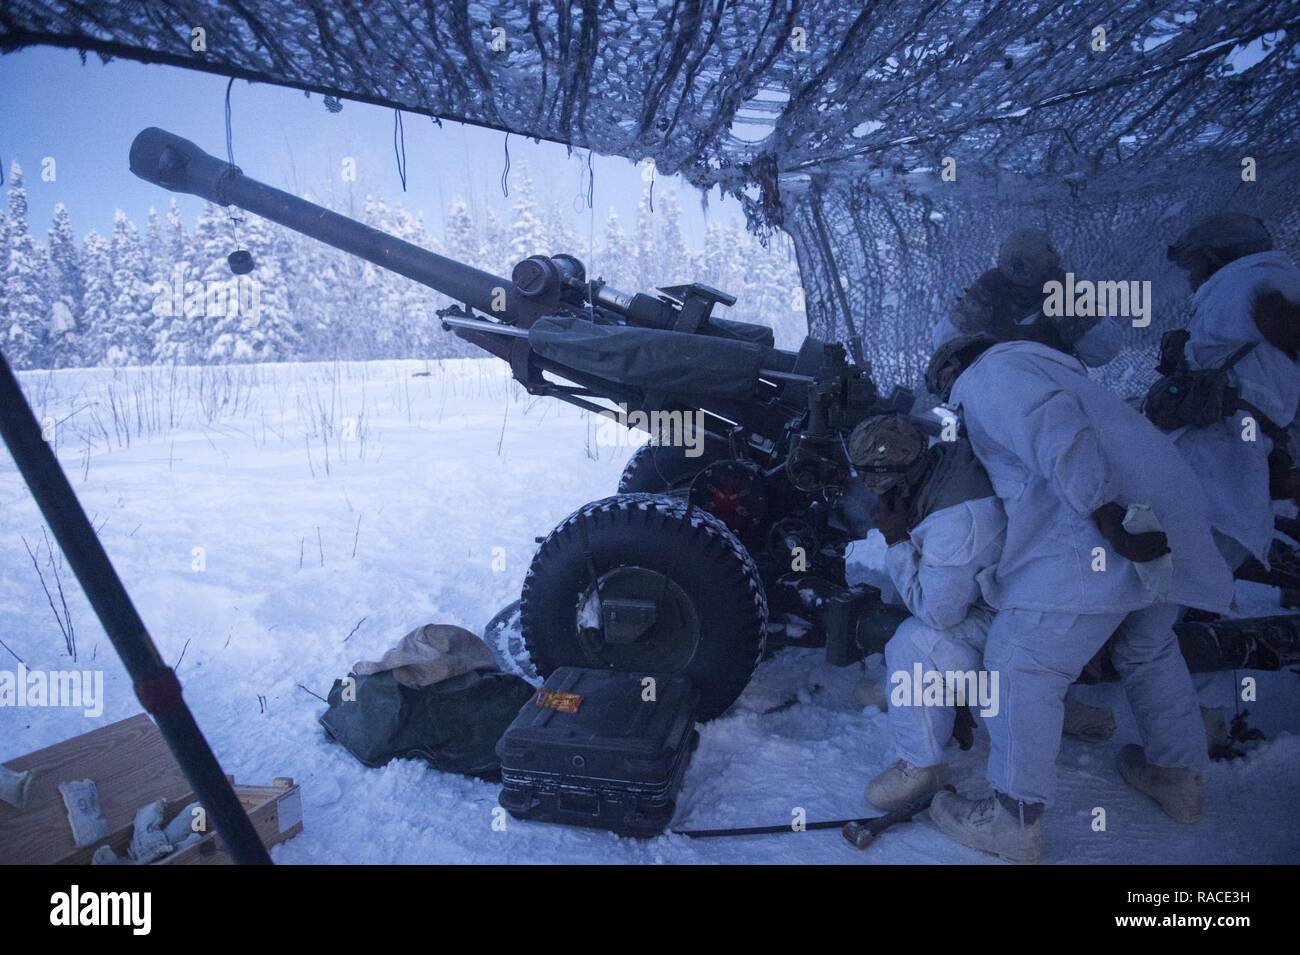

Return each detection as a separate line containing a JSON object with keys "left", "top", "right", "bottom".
{"left": 1143, "top": 329, "right": 1255, "bottom": 431}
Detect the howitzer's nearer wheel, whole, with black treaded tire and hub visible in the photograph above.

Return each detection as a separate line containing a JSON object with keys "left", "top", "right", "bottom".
{"left": 520, "top": 494, "right": 767, "bottom": 720}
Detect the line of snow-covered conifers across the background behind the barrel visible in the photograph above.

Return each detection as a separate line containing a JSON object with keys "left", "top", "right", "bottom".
{"left": 0, "top": 153, "right": 805, "bottom": 366}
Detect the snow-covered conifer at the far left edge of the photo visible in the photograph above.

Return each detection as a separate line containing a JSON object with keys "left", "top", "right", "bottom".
{"left": 4, "top": 161, "right": 48, "bottom": 368}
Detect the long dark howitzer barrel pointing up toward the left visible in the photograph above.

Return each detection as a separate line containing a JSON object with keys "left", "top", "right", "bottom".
{"left": 130, "top": 126, "right": 515, "bottom": 322}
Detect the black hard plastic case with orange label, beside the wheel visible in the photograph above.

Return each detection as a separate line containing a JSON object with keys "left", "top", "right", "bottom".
{"left": 497, "top": 667, "right": 699, "bottom": 837}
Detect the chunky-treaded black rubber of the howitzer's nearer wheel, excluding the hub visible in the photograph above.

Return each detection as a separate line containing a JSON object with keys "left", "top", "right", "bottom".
{"left": 520, "top": 494, "right": 767, "bottom": 720}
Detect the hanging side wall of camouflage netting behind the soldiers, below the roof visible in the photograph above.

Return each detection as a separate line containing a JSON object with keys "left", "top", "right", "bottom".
{"left": 787, "top": 162, "right": 1300, "bottom": 395}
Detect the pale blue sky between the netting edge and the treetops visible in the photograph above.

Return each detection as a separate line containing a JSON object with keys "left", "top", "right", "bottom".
{"left": 0, "top": 48, "right": 744, "bottom": 246}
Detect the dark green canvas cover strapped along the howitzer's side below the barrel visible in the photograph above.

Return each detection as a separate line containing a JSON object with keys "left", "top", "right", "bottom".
{"left": 528, "top": 317, "right": 764, "bottom": 399}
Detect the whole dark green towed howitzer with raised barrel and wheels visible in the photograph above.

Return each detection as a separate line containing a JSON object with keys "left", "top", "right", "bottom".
{"left": 130, "top": 127, "right": 913, "bottom": 719}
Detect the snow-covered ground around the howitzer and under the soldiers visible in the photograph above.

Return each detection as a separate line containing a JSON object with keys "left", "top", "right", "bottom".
{"left": 0, "top": 360, "right": 1300, "bottom": 864}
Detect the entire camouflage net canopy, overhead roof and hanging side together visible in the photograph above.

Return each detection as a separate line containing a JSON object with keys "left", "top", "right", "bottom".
{"left": 0, "top": 0, "right": 1300, "bottom": 381}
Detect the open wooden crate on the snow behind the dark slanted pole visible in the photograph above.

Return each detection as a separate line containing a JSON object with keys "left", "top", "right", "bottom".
{"left": 0, "top": 713, "right": 303, "bottom": 865}
